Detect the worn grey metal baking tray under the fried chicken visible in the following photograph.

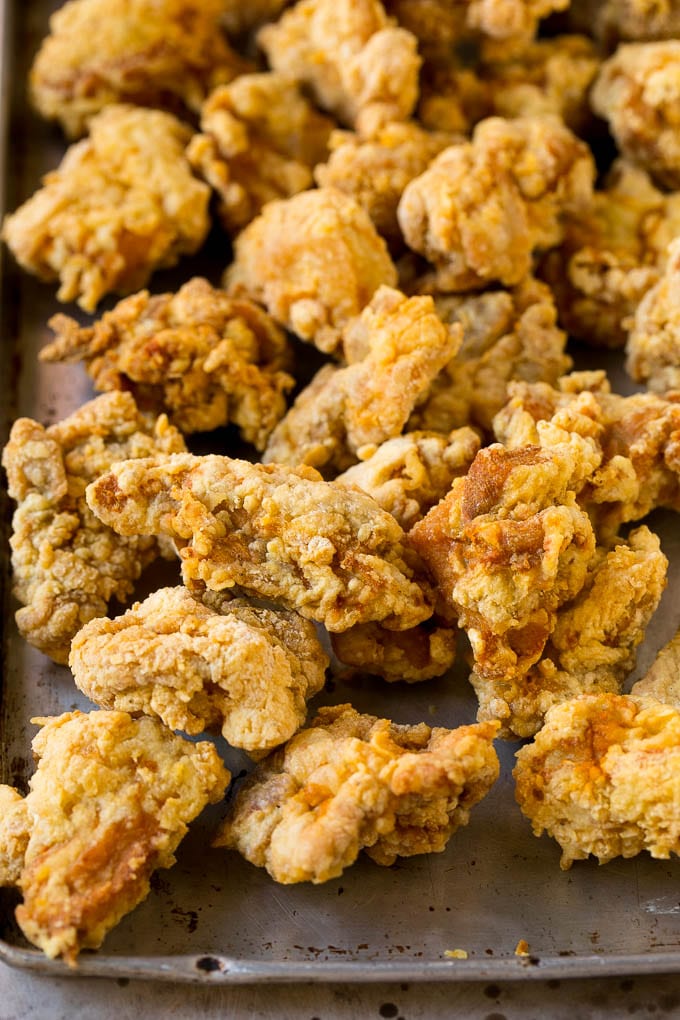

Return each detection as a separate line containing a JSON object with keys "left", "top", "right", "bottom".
{"left": 0, "top": 0, "right": 680, "bottom": 983}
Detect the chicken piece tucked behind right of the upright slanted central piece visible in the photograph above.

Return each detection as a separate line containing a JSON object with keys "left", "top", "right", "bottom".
{"left": 409, "top": 276, "right": 572, "bottom": 432}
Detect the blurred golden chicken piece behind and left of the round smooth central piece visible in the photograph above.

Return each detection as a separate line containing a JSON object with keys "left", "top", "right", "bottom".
{"left": 187, "top": 71, "right": 333, "bottom": 234}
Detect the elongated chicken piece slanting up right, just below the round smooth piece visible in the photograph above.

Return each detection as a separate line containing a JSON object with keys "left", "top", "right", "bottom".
{"left": 263, "top": 287, "right": 461, "bottom": 476}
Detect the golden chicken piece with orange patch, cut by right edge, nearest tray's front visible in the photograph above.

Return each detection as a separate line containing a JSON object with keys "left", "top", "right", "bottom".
{"left": 514, "top": 694, "right": 680, "bottom": 870}
